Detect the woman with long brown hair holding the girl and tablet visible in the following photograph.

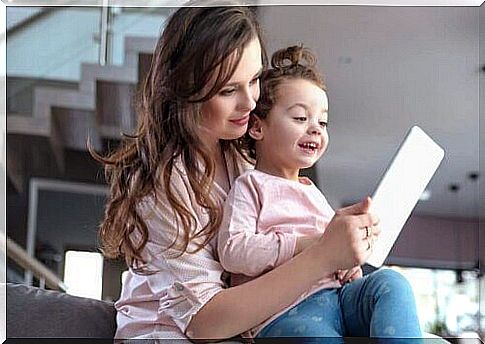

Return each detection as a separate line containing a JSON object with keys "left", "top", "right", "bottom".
{"left": 93, "top": 7, "right": 377, "bottom": 338}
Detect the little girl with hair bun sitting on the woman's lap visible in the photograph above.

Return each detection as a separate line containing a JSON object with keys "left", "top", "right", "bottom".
{"left": 218, "top": 46, "right": 421, "bottom": 342}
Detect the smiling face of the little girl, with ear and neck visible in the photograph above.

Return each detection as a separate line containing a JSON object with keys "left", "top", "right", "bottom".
{"left": 250, "top": 79, "right": 328, "bottom": 179}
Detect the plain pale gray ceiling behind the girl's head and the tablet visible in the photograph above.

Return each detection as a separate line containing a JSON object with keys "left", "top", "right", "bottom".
{"left": 258, "top": 6, "right": 485, "bottom": 217}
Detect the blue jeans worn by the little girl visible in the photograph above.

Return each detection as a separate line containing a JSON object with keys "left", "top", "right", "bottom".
{"left": 257, "top": 269, "right": 422, "bottom": 343}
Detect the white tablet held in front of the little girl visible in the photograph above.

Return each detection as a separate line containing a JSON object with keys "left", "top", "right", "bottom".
{"left": 367, "top": 126, "right": 445, "bottom": 267}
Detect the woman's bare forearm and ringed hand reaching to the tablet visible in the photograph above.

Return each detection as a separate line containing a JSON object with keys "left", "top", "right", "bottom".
{"left": 186, "top": 198, "right": 378, "bottom": 339}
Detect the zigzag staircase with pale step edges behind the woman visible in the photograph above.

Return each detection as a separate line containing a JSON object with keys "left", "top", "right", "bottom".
{"left": 7, "top": 37, "right": 156, "bottom": 193}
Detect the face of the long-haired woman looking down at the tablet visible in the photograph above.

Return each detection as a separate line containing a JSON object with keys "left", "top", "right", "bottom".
{"left": 201, "top": 38, "right": 262, "bottom": 145}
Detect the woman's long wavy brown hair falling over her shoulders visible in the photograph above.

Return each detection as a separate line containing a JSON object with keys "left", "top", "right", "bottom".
{"left": 91, "top": 7, "right": 266, "bottom": 272}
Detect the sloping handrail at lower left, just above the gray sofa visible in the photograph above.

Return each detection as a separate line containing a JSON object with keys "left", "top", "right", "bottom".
{"left": 0, "top": 232, "right": 67, "bottom": 291}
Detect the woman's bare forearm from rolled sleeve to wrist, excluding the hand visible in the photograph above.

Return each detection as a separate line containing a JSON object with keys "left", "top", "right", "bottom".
{"left": 186, "top": 243, "right": 335, "bottom": 339}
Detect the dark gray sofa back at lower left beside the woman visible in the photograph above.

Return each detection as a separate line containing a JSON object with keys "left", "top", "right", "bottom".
{"left": 7, "top": 283, "right": 116, "bottom": 338}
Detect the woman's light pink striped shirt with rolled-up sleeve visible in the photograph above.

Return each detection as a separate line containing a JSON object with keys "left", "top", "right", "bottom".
{"left": 115, "top": 154, "right": 249, "bottom": 339}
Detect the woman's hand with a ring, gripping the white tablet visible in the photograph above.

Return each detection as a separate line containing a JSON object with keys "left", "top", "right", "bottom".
{"left": 317, "top": 197, "right": 380, "bottom": 271}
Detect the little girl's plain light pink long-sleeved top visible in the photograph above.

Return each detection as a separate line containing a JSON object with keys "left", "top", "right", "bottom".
{"left": 218, "top": 170, "right": 341, "bottom": 336}
